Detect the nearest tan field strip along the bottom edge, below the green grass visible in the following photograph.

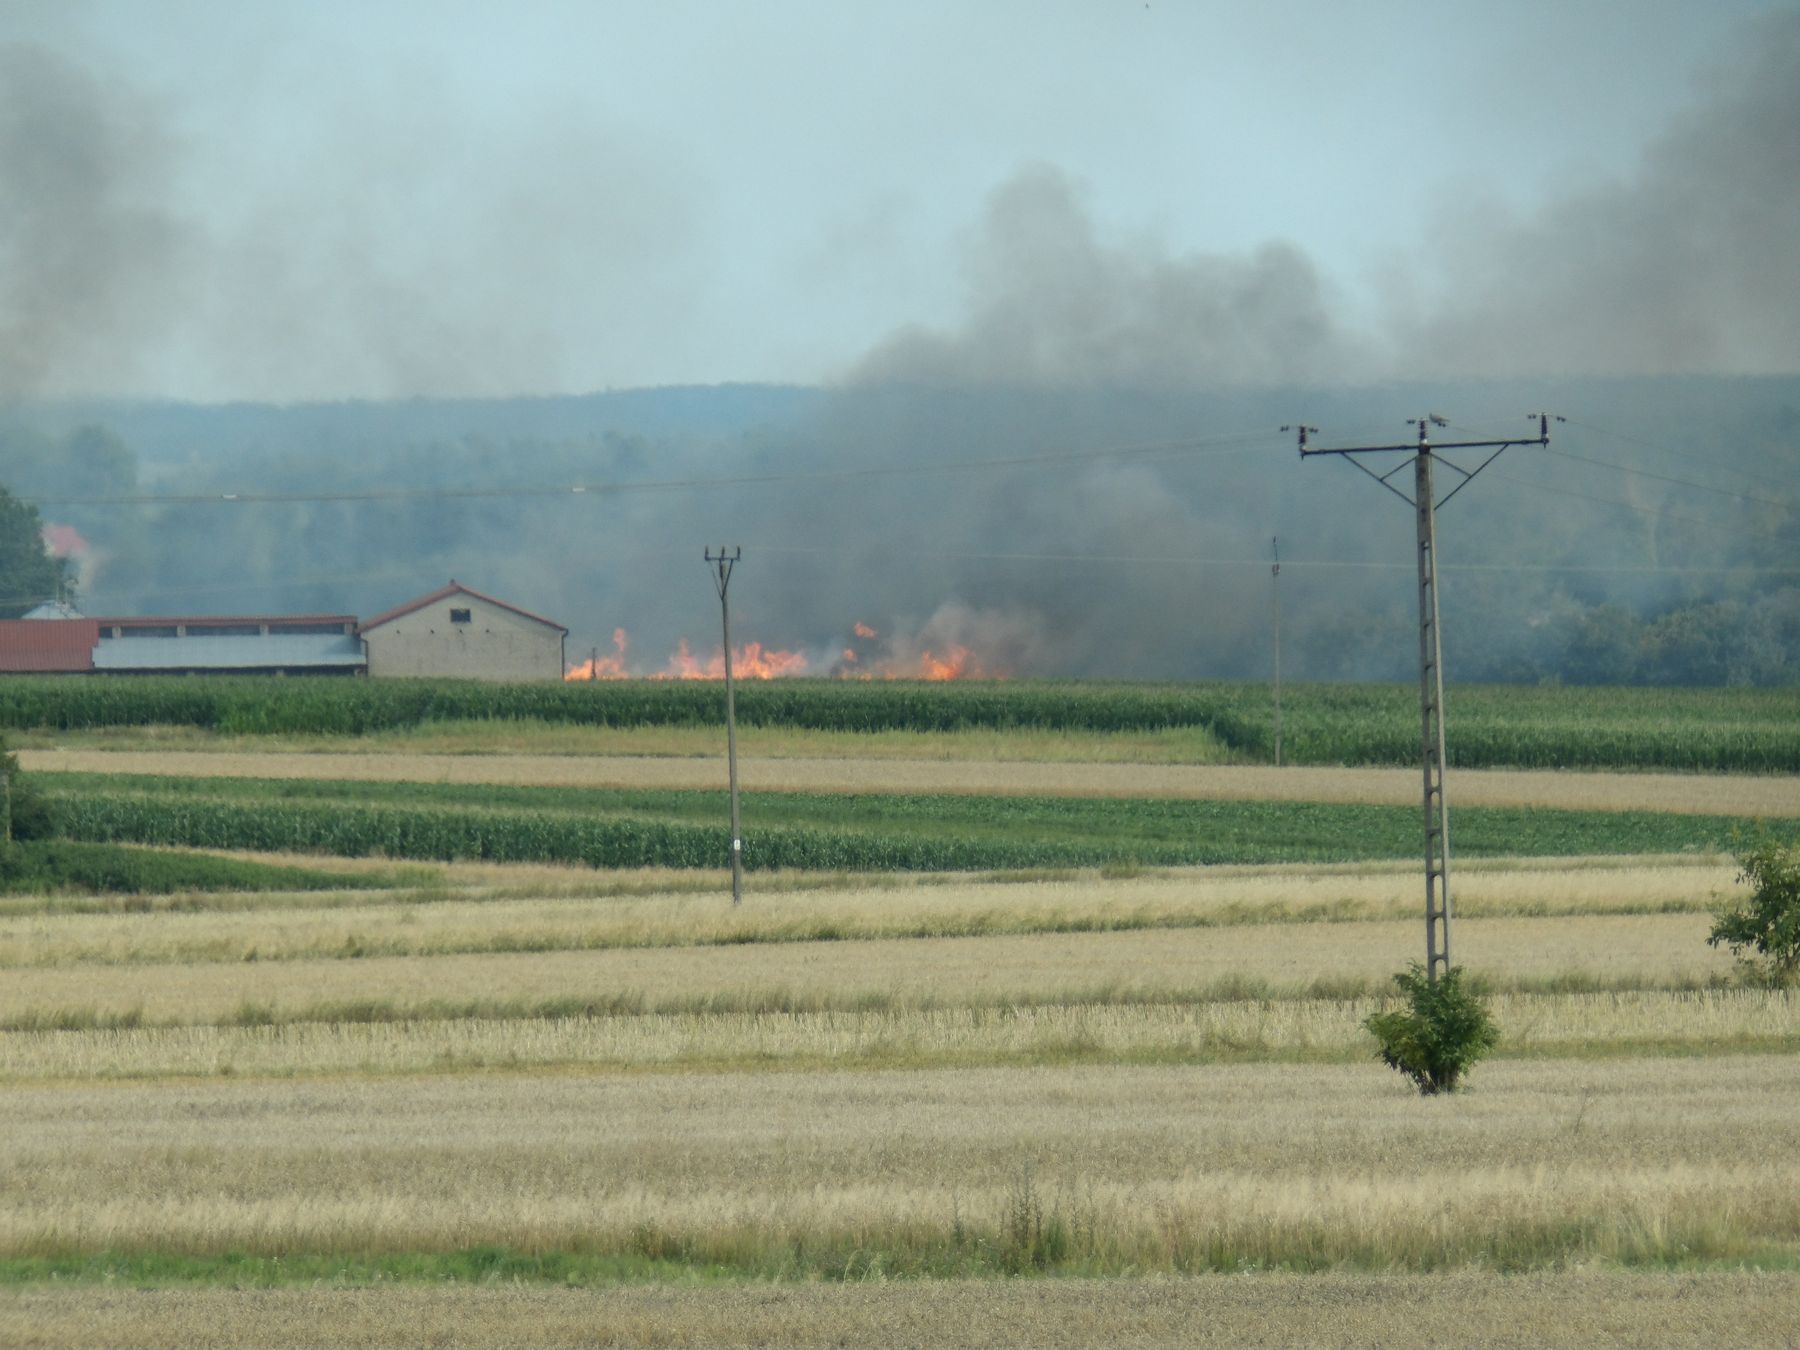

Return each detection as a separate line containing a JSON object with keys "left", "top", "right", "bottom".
{"left": 14, "top": 1271, "right": 1800, "bottom": 1350}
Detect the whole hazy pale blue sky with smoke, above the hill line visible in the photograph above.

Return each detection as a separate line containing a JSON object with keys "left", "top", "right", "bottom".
{"left": 0, "top": 0, "right": 1800, "bottom": 400}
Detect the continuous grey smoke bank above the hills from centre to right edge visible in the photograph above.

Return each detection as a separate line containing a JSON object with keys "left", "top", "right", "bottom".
{"left": 848, "top": 14, "right": 1800, "bottom": 389}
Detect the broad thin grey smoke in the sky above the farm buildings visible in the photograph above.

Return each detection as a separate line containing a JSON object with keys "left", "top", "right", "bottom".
{"left": 0, "top": 43, "right": 697, "bottom": 398}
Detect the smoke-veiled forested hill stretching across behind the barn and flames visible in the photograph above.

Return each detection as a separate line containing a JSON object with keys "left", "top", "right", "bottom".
{"left": 0, "top": 378, "right": 1800, "bottom": 684}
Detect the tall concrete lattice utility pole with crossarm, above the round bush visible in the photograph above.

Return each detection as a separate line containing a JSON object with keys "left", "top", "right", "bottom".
{"left": 1282, "top": 412, "right": 1562, "bottom": 985}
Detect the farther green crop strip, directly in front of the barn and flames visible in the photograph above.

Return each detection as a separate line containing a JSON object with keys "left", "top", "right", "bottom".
{"left": 0, "top": 677, "right": 1800, "bottom": 774}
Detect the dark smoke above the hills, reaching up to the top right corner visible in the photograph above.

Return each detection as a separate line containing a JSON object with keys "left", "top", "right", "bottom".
{"left": 1395, "top": 14, "right": 1800, "bottom": 376}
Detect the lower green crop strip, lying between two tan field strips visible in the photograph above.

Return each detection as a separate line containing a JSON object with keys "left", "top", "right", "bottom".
{"left": 40, "top": 774, "right": 1751, "bottom": 871}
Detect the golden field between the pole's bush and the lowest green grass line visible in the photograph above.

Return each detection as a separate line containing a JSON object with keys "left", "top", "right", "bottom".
{"left": 0, "top": 1055, "right": 1800, "bottom": 1273}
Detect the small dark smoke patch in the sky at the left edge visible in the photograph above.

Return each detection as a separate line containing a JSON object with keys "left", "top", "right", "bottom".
{"left": 0, "top": 45, "right": 187, "bottom": 400}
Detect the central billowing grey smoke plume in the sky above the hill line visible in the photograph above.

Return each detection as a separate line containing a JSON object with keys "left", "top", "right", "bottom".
{"left": 850, "top": 166, "right": 1355, "bottom": 387}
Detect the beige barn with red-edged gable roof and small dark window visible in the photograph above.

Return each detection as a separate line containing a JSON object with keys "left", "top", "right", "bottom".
{"left": 356, "top": 580, "right": 569, "bottom": 680}
